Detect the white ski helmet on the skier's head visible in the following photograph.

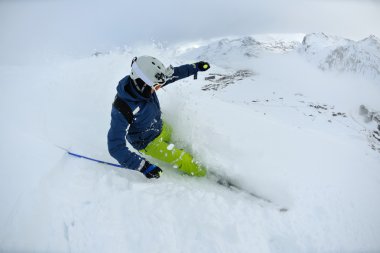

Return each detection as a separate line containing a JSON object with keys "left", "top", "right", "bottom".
{"left": 131, "top": 56, "right": 174, "bottom": 87}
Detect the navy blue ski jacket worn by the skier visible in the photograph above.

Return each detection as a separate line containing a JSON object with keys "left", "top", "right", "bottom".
{"left": 108, "top": 64, "right": 198, "bottom": 170}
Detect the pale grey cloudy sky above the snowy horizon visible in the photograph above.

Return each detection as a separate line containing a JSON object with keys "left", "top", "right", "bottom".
{"left": 0, "top": 0, "right": 380, "bottom": 64}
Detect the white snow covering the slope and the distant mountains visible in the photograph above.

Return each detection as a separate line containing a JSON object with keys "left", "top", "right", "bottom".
{"left": 0, "top": 34, "right": 380, "bottom": 252}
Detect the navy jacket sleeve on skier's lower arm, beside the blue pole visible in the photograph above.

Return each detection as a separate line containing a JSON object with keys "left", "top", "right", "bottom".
{"left": 107, "top": 108, "right": 145, "bottom": 170}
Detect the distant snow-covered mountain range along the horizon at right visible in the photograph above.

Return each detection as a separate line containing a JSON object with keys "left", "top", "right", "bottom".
{"left": 179, "top": 33, "right": 380, "bottom": 78}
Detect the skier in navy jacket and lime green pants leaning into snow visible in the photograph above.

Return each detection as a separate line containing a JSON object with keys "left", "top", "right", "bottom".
{"left": 108, "top": 56, "right": 210, "bottom": 178}
